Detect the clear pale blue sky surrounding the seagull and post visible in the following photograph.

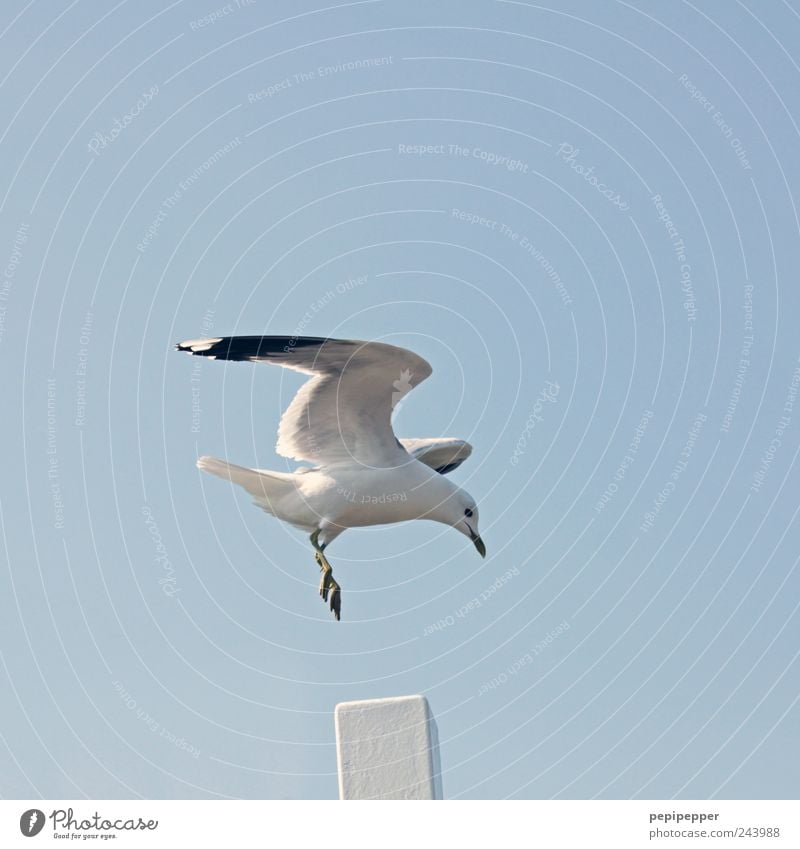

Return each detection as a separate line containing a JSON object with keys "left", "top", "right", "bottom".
{"left": 0, "top": 0, "right": 800, "bottom": 798}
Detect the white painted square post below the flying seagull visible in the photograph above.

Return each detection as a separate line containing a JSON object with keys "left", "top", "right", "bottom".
{"left": 336, "top": 696, "right": 442, "bottom": 799}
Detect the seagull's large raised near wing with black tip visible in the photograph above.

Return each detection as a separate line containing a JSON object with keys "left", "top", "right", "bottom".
{"left": 176, "top": 336, "right": 432, "bottom": 467}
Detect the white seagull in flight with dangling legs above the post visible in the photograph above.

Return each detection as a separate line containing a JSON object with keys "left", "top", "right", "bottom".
{"left": 175, "top": 336, "right": 486, "bottom": 621}
